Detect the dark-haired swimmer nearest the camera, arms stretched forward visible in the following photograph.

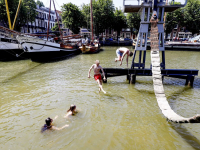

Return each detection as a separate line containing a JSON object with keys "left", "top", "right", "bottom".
{"left": 41, "top": 116, "right": 69, "bottom": 132}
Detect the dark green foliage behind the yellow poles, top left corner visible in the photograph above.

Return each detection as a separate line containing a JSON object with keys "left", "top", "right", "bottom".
{"left": 0, "top": 0, "right": 37, "bottom": 31}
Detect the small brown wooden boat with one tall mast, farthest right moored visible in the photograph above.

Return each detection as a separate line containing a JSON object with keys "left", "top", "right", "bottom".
{"left": 79, "top": 0, "right": 100, "bottom": 54}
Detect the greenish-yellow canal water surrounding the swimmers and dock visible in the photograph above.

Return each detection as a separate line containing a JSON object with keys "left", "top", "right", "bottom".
{"left": 0, "top": 47, "right": 200, "bottom": 150}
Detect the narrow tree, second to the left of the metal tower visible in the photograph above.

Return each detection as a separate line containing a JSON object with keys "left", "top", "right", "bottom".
{"left": 113, "top": 8, "right": 127, "bottom": 40}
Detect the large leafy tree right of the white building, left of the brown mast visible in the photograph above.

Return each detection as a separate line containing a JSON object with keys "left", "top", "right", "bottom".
{"left": 62, "top": 3, "right": 85, "bottom": 34}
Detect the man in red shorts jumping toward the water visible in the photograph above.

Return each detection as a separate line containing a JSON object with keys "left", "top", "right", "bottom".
{"left": 88, "top": 60, "right": 106, "bottom": 94}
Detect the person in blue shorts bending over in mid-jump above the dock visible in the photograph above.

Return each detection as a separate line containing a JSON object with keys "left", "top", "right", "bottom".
{"left": 115, "top": 47, "right": 133, "bottom": 67}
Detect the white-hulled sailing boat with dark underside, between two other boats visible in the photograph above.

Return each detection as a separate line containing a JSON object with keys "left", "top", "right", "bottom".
{"left": 17, "top": 0, "right": 79, "bottom": 62}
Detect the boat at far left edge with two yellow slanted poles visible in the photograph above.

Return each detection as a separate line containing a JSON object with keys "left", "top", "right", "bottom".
{"left": 0, "top": 0, "right": 29, "bottom": 61}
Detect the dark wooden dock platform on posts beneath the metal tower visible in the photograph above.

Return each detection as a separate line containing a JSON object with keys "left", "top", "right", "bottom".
{"left": 103, "top": 68, "right": 199, "bottom": 86}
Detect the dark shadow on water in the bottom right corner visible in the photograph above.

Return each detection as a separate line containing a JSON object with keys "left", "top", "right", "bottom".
{"left": 169, "top": 122, "right": 200, "bottom": 150}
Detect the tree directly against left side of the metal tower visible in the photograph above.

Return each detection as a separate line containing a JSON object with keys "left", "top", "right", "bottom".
{"left": 126, "top": 13, "right": 141, "bottom": 38}
